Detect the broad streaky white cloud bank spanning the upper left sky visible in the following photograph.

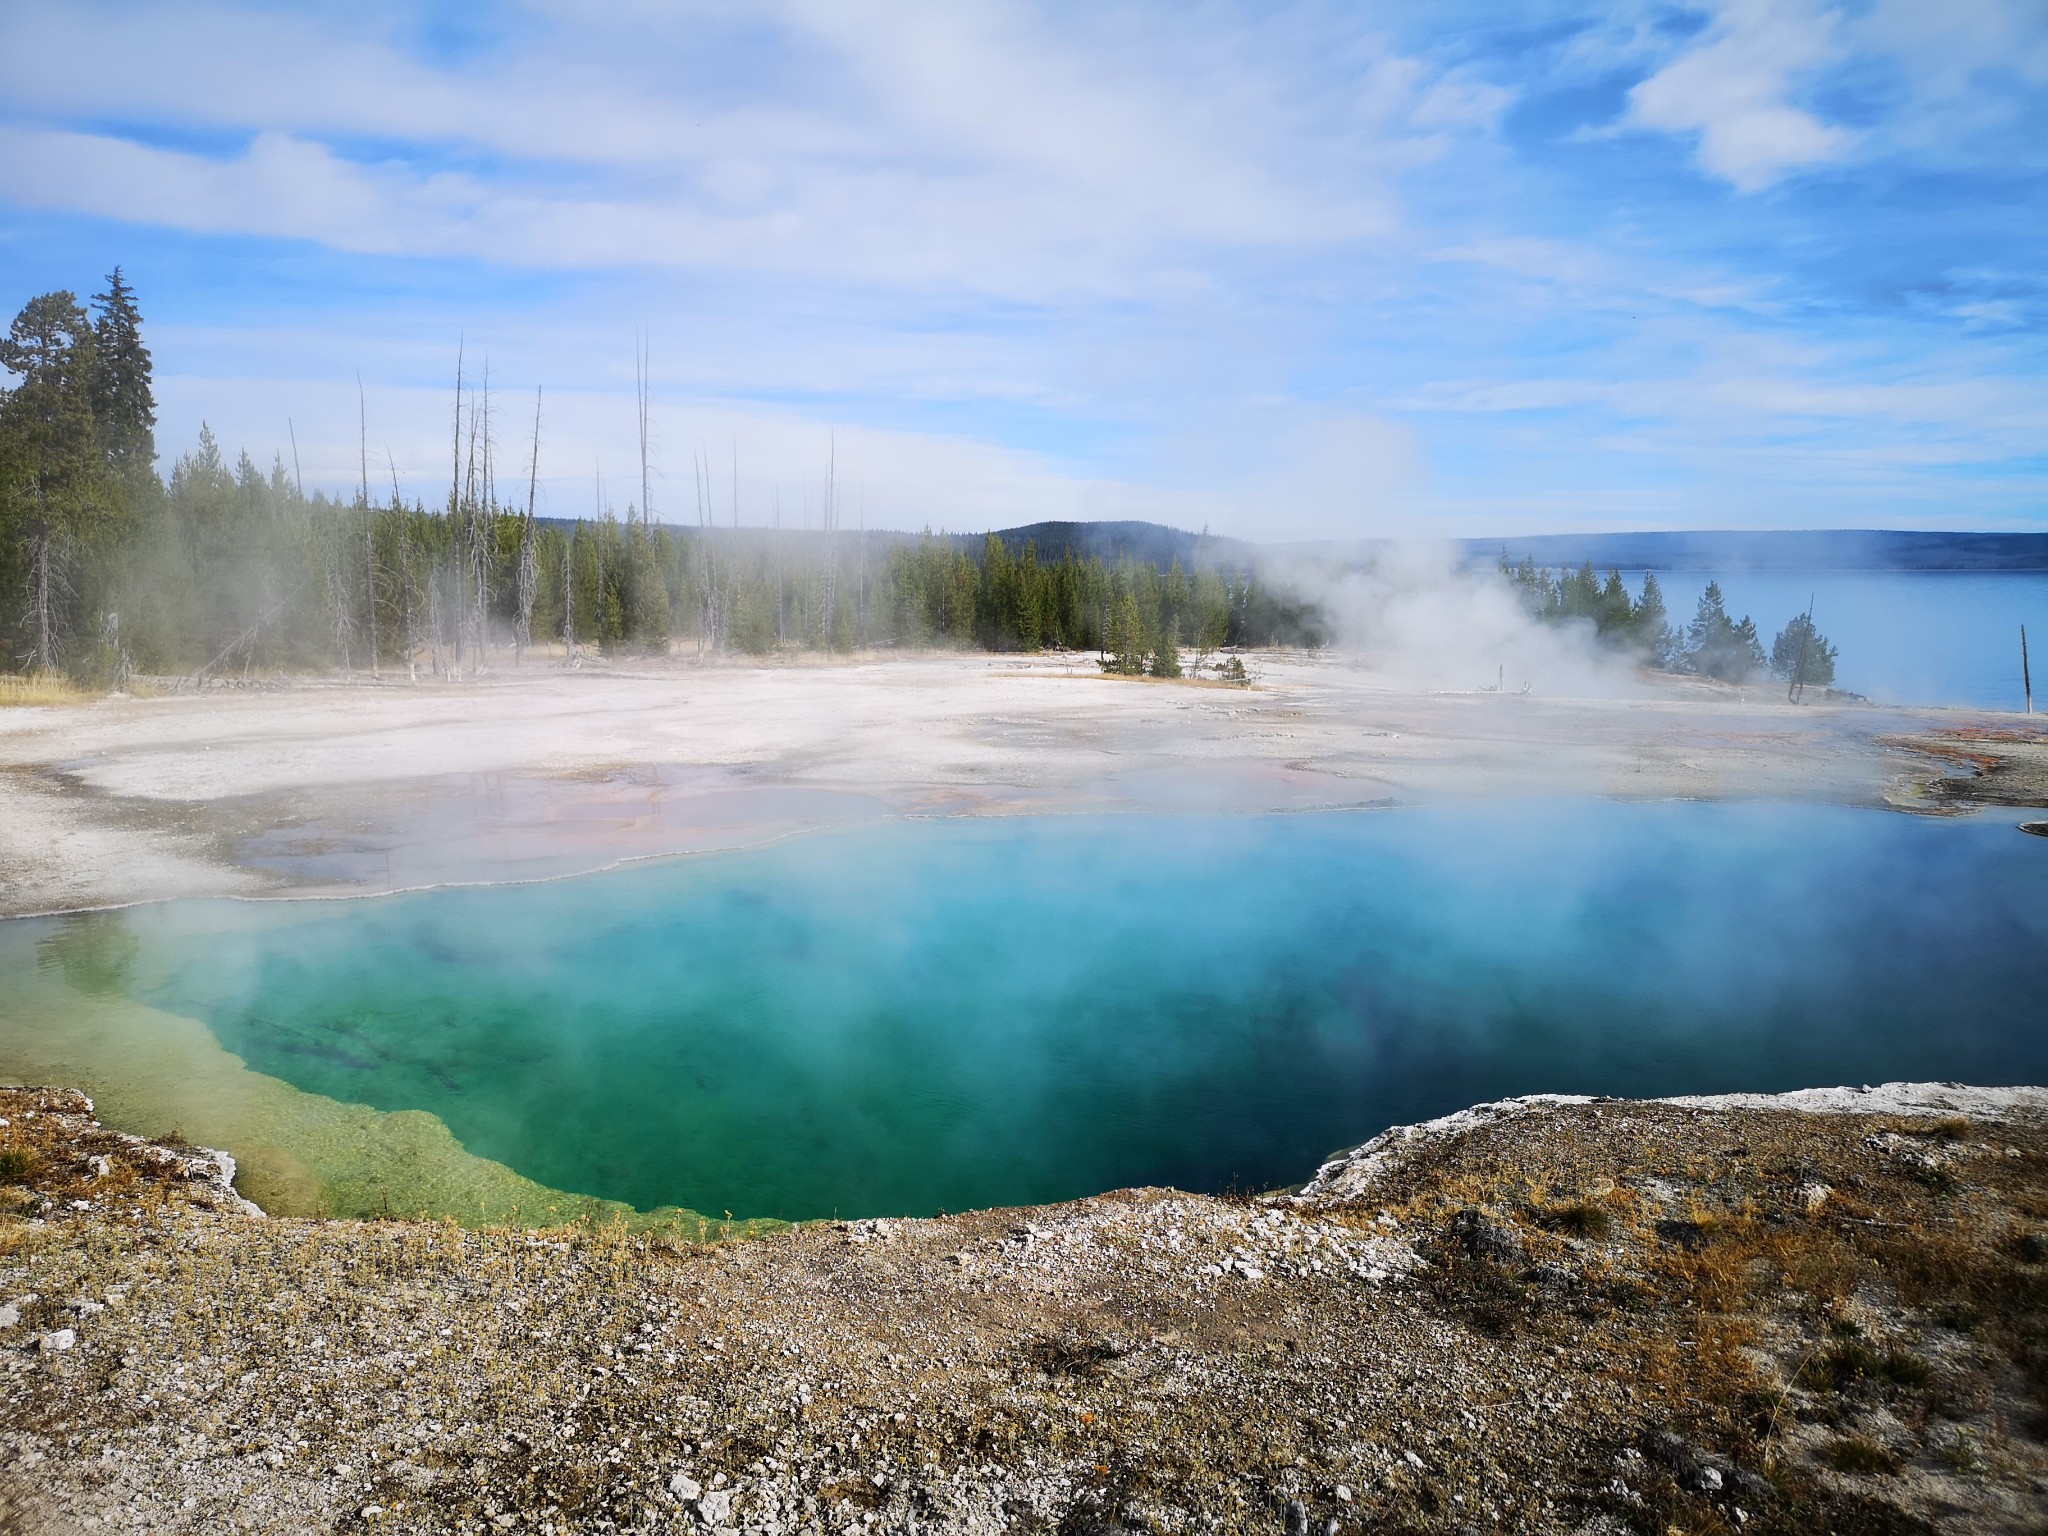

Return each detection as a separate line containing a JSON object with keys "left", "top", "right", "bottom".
{"left": 0, "top": 0, "right": 1501, "bottom": 301}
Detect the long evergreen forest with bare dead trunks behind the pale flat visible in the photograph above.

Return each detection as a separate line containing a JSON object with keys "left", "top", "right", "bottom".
{"left": 0, "top": 270, "right": 1325, "bottom": 686}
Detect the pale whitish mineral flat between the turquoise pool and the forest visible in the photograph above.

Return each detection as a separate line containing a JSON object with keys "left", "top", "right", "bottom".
{"left": 0, "top": 653, "right": 2048, "bottom": 915}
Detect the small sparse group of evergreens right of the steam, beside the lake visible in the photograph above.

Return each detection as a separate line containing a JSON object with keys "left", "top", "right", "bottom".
{"left": 1501, "top": 555, "right": 1837, "bottom": 690}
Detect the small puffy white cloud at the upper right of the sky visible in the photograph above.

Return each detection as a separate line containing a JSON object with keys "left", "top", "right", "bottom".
{"left": 1628, "top": 0, "right": 1855, "bottom": 193}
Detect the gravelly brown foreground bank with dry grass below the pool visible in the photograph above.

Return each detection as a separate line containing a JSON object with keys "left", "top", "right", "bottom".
{"left": 0, "top": 1083, "right": 2048, "bottom": 1534}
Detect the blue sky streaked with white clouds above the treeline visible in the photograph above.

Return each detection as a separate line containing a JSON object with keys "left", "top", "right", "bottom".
{"left": 0, "top": 0, "right": 2048, "bottom": 541}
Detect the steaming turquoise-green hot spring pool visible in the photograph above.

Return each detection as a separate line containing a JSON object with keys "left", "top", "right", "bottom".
{"left": 28, "top": 803, "right": 2048, "bottom": 1217}
